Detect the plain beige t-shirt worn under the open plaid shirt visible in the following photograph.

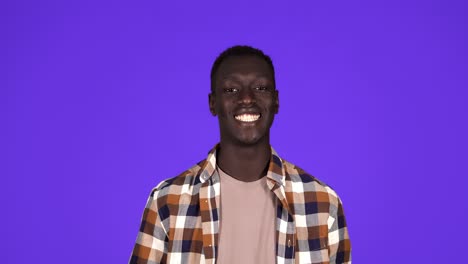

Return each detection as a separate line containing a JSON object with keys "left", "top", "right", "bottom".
{"left": 217, "top": 168, "right": 276, "bottom": 264}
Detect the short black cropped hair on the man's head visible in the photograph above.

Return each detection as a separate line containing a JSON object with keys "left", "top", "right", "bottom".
{"left": 210, "top": 45, "right": 275, "bottom": 92}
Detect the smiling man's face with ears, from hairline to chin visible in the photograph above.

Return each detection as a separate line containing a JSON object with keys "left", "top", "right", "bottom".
{"left": 209, "top": 56, "right": 279, "bottom": 145}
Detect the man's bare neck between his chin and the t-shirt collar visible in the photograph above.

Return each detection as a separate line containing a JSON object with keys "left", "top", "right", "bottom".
{"left": 217, "top": 141, "right": 271, "bottom": 182}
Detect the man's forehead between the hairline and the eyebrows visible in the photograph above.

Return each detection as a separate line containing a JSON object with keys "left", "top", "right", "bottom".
{"left": 216, "top": 55, "right": 273, "bottom": 80}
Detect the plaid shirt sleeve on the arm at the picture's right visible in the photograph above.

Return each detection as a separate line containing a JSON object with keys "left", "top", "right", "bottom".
{"left": 328, "top": 195, "right": 351, "bottom": 264}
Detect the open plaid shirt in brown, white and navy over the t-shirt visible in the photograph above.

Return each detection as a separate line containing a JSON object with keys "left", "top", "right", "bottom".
{"left": 130, "top": 147, "right": 351, "bottom": 264}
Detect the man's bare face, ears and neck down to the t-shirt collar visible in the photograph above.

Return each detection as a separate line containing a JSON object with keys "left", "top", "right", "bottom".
{"left": 209, "top": 55, "right": 279, "bottom": 182}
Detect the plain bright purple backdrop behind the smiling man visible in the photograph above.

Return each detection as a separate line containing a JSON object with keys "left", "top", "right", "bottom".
{"left": 0, "top": 0, "right": 468, "bottom": 263}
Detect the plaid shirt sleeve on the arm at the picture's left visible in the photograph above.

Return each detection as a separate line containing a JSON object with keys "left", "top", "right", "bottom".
{"left": 129, "top": 190, "right": 168, "bottom": 264}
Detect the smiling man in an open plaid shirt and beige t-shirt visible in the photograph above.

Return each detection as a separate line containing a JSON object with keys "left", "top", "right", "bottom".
{"left": 130, "top": 46, "right": 351, "bottom": 264}
